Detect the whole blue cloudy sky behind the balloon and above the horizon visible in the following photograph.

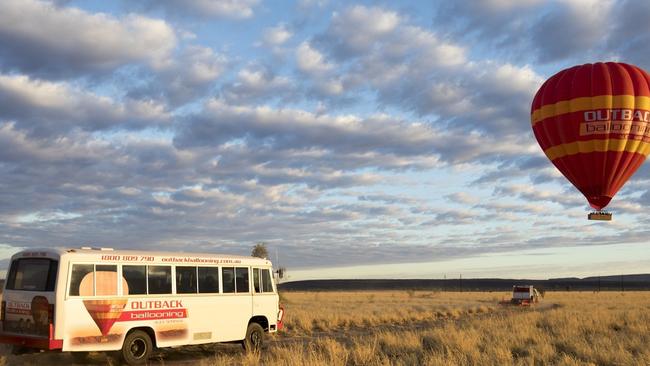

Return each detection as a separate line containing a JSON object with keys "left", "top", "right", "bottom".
{"left": 0, "top": 0, "right": 650, "bottom": 280}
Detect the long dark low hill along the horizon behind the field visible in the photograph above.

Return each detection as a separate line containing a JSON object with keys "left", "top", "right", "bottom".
{"left": 279, "top": 274, "right": 650, "bottom": 291}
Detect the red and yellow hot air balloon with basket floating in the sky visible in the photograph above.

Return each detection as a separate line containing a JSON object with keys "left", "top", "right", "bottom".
{"left": 531, "top": 62, "right": 650, "bottom": 220}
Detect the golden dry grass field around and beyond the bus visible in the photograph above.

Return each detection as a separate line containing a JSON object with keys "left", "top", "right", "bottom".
{"left": 2, "top": 291, "right": 650, "bottom": 365}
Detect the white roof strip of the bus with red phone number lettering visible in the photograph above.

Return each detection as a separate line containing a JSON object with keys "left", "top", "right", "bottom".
{"left": 11, "top": 247, "right": 271, "bottom": 266}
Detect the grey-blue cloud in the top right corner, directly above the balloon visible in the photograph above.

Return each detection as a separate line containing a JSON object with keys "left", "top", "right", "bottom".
{"left": 434, "top": 0, "right": 650, "bottom": 68}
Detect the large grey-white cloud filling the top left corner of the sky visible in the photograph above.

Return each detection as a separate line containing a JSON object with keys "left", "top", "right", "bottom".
{"left": 0, "top": 0, "right": 176, "bottom": 79}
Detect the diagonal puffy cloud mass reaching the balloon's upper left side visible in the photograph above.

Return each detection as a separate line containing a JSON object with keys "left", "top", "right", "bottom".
{"left": 298, "top": 6, "right": 543, "bottom": 140}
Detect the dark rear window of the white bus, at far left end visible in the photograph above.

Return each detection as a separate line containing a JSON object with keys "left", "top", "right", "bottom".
{"left": 7, "top": 258, "right": 59, "bottom": 291}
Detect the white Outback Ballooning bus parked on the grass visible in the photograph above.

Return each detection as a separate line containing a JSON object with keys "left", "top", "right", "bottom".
{"left": 0, "top": 247, "right": 284, "bottom": 365}
